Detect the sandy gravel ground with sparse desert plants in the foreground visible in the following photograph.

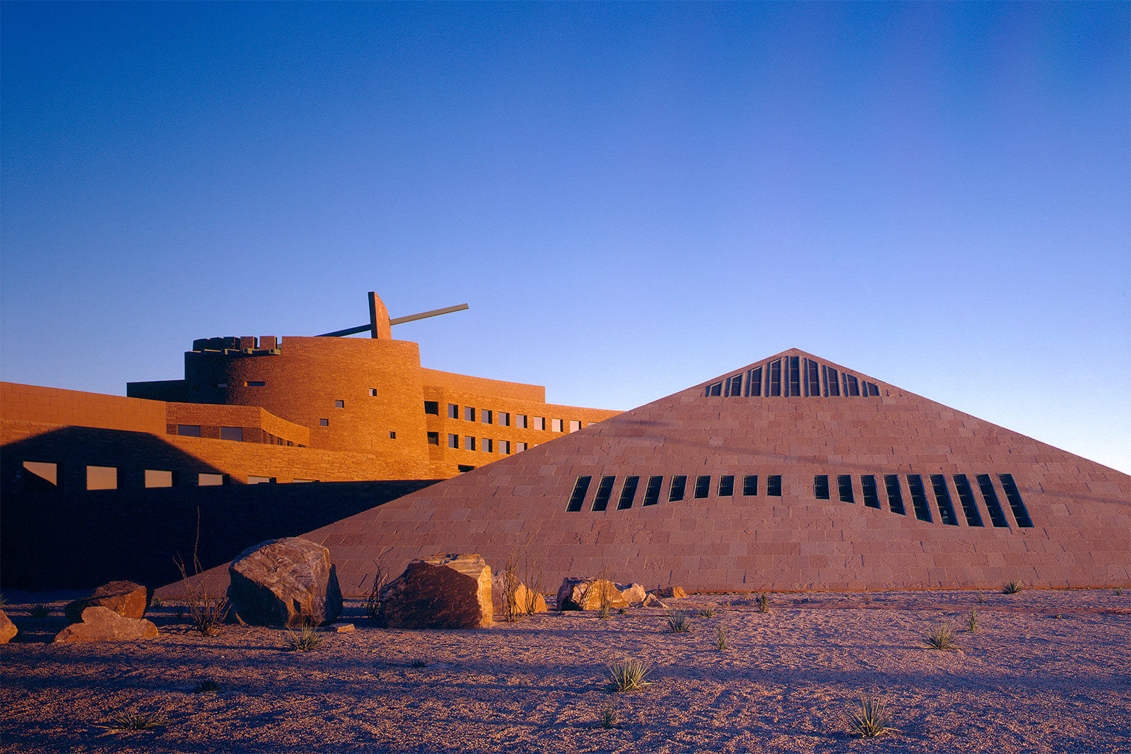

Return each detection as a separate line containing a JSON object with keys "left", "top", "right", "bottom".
{"left": 0, "top": 590, "right": 1131, "bottom": 754}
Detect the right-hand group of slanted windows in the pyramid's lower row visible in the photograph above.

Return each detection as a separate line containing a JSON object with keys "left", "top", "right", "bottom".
{"left": 813, "top": 474, "right": 1033, "bottom": 529}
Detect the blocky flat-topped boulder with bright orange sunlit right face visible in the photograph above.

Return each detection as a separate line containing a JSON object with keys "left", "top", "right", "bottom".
{"left": 379, "top": 555, "right": 493, "bottom": 629}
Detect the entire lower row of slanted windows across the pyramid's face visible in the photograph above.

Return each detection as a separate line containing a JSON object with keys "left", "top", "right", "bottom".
{"left": 566, "top": 474, "right": 1034, "bottom": 529}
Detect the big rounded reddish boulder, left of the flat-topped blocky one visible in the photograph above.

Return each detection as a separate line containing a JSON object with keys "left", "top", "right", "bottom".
{"left": 227, "top": 537, "right": 342, "bottom": 627}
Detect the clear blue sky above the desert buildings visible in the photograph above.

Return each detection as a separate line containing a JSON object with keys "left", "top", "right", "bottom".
{"left": 0, "top": 2, "right": 1131, "bottom": 471}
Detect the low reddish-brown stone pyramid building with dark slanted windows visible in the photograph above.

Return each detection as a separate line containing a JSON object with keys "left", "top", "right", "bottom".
{"left": 307, "top": 349, "right": 1131, "bottom": 592}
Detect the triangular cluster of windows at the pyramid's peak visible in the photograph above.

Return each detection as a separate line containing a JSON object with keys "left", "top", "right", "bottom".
{"left": 706, "top": 356, "right": 880, "bottom": 398}
